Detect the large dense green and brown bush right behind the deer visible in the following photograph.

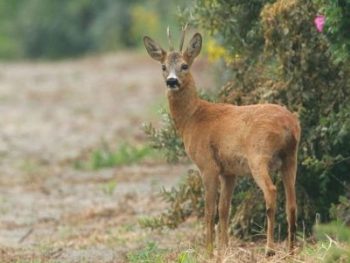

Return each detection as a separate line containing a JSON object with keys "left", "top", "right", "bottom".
{"left": 142, "top": 0, "right": 350, "bottom": 241}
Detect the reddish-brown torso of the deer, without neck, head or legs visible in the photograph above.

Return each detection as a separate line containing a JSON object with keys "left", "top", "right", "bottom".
{"left": 183, "top": 101, "right": 300, "bottom": 174}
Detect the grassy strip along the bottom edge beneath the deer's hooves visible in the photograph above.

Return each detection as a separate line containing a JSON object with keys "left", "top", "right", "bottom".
{"left": 127, "top": 225, "right": 350, "bottom": 263}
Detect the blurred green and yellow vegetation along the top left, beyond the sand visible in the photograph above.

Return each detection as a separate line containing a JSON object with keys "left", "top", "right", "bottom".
{"left": 0, "top": 0, "right": 186, "bottom": 59}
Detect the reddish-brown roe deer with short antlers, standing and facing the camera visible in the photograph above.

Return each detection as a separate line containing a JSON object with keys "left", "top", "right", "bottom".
{"left": 143, "top": 27, "right": 300, "bottom": 256}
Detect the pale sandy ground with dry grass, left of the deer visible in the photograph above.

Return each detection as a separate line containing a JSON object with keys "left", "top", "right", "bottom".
{"left": 0, "top": 53, "right": 211, "bottom": 262}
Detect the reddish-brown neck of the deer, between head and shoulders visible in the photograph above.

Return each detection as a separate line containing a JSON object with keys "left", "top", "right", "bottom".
{"left": 168, "top": 76, "right": 200, "bottom": 136}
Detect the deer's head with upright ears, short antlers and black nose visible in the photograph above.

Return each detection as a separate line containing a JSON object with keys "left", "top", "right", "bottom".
{"left": 143, "top": 27, "right": 202, "bottom": 91}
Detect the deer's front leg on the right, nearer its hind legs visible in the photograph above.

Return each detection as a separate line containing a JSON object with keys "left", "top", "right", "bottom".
{"left": 202, "top": 169, "right": 219, "bottom": 256}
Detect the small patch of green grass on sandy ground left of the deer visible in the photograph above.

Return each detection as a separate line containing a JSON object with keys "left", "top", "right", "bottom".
{"left": 75, "top": 142, "right": 153, "bottom": 170}
